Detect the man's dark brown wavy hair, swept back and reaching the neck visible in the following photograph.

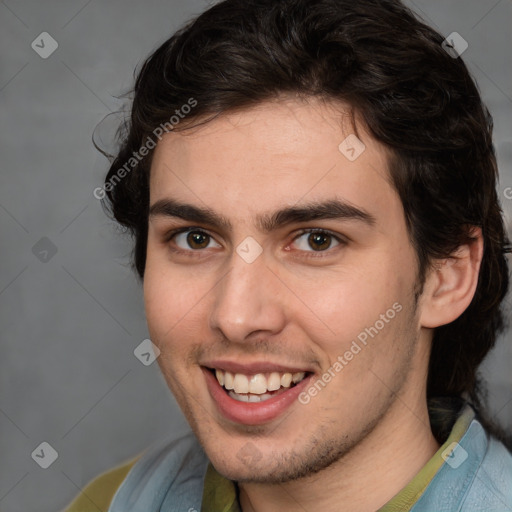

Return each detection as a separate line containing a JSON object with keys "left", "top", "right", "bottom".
{"left": 100, "top": 0, "right": 510, "bottom": 437}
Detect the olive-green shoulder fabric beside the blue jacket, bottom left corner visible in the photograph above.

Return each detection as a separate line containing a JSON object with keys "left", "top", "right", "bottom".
{"left": 64, "top": 456, "right": 140, "bottom": 512}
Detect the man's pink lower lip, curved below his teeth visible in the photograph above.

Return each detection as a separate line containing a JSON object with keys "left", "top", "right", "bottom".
{"left": 202, "top": 368, "right": 311, "bottom": 425}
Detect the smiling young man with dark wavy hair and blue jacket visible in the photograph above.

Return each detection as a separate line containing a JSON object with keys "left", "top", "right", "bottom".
{"left": 69, "top": 0, "right": 512, "bottom": 512}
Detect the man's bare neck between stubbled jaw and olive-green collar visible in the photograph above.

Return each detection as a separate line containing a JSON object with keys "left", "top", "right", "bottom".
{"left": 239, "top": 397, "right": 439, "bottom": 512}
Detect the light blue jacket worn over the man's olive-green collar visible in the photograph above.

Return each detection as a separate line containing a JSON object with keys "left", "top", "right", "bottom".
{"left": 109, "top": 410, "right": 512, "bottom": 512}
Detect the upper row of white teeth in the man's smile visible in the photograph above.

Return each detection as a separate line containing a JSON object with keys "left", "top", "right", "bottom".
{"left": 215, "top": 369, "right": 306, "bottom": 394}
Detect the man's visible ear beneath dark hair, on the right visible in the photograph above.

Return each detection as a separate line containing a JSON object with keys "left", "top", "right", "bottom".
{"left": 420, "top": 227, "right": 484, "bottom": 328}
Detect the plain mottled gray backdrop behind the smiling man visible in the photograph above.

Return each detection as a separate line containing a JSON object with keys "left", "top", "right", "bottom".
{"left": 0, "top": 0, "right": 512, "bottom": 512}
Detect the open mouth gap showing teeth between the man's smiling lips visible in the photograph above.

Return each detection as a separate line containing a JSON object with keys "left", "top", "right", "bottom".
{"left": 208, "top": 368, "right": 309, "bottom": 403}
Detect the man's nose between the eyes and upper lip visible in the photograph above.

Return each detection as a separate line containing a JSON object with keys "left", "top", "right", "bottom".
{"left": 210, "top": 249, "right": 286, "bottom": 343}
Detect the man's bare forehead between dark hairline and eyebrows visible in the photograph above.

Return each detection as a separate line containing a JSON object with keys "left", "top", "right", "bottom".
{"left": 150, "top": 99, "right": 401, "bottom": 226}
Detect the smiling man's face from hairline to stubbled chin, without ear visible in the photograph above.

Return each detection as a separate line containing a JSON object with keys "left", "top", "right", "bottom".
{"left": 144, "top": 100, "right": 428, "bottom": 482}
